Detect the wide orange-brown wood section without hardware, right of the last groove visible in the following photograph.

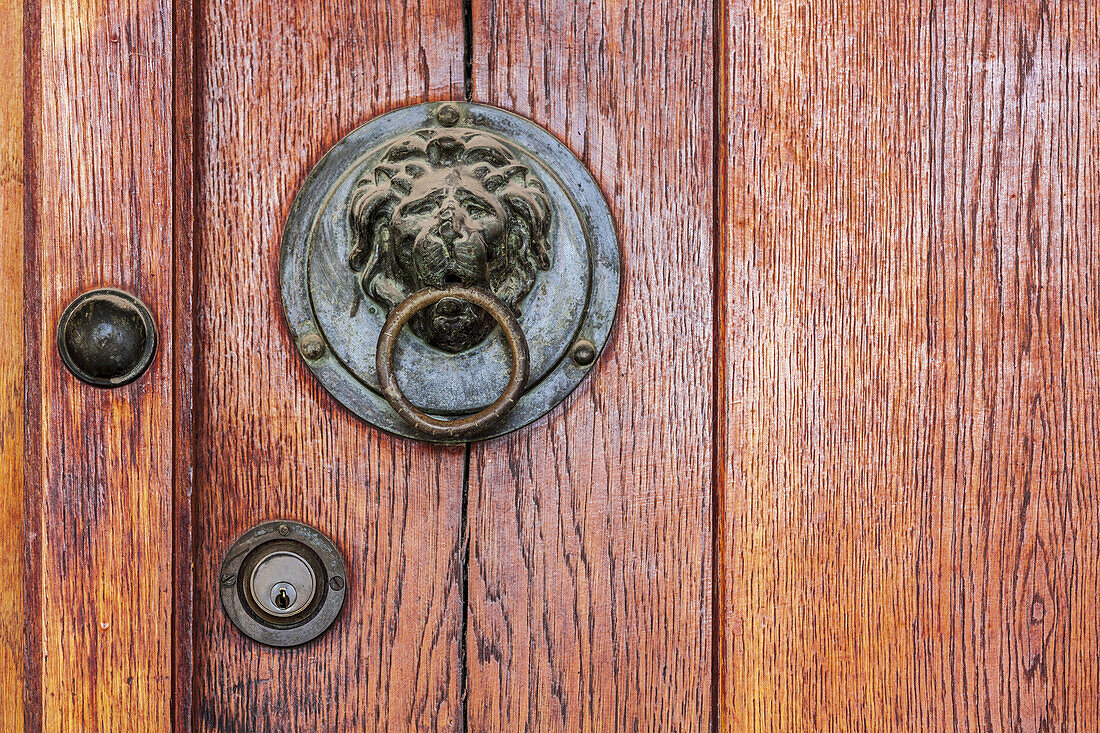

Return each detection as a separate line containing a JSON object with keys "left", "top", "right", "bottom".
{"left": 717, "top": 2, "right": 1100, "bottom": 731}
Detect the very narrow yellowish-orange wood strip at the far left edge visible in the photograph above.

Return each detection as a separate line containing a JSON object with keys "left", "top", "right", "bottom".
{"left": 0, "top": 1, "right": 26, "bottom": 732}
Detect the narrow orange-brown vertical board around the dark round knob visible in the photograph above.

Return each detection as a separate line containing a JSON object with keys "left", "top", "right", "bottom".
{"left": 24, "top": 0, "right": 180, "bottom": 731}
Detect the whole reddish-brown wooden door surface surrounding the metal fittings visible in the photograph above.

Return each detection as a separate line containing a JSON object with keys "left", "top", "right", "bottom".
{"left": 0, "top": 0, "right": 1100, "bottom": 731}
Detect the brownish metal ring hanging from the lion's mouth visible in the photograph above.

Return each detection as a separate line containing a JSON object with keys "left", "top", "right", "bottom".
{"left": 375, "top": 286, "right": 531, "bottom": 439}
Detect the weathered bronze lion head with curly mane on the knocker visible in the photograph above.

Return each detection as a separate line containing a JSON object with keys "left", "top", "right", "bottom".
{"left": 349, "top": 128, "right": 551, "bottom": 353}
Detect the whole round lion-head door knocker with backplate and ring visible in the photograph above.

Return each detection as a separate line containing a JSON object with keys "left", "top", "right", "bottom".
{"left": 281, "top": 102, "right": 619, "bottom": 442}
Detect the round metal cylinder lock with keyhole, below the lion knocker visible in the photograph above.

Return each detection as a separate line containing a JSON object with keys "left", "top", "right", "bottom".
{"left": 219, "top": 519, "right": 348, "bottom": 647}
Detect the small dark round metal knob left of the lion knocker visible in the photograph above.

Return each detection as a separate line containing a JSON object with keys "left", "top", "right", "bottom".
{"left": 57, "top": 287, "right": 156, "bottom": 387}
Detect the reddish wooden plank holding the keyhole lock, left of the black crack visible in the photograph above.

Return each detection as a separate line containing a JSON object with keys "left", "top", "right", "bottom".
{"left": 195, "top": 0, "right": 464, "bottom": 731}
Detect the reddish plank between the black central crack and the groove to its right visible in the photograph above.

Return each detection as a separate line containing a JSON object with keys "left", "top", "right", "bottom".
{"left": 466, "top": 0, "right": 714, "bottom": 731}
